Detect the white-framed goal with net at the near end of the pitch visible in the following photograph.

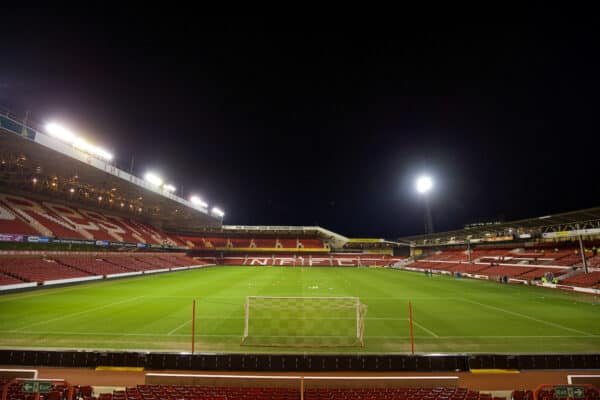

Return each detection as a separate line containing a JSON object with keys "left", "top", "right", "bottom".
{"left": 242, "top": 296, "right": 367, "bottom": 347}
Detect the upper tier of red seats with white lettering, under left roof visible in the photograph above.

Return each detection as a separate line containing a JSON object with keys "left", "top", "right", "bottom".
{"left": 0, "top": 193, "right": 183, "bottom": 246}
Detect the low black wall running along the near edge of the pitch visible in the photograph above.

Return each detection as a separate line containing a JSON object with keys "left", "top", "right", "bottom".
{"left": 0, "top": 350, "right": 600, "bottom": 372}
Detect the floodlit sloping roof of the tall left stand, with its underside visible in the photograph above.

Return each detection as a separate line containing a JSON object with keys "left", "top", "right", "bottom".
{"left": 0, "top": 114, "right": 222, "bottom": 230}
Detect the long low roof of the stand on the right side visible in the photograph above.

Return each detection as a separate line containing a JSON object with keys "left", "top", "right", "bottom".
{"left": 399, "top": 207, "right": 600, "bottom": 245}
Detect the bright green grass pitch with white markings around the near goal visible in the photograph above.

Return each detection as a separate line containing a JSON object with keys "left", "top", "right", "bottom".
{"left": 0, "top": 267, "right": 600, "bottom": 353}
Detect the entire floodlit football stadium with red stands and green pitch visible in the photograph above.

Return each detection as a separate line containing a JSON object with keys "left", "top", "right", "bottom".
{"left": 0, "top": 108, "right": 600, "bottom": 400}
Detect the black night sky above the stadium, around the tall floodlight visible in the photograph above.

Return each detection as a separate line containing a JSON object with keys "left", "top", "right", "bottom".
{"left": 0, "top": 8, "right": 600, "bottom": 238}
